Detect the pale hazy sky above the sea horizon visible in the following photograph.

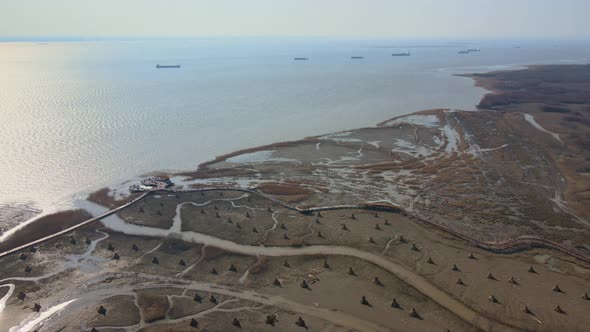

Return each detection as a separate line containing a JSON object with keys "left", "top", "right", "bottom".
{"left": 0, "top": 0, "right": 590, "bottom": 38}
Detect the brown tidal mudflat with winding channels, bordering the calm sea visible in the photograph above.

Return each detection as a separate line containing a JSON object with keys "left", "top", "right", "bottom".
{"left": 0, "top": 66, "right": 590, "bottom": 331}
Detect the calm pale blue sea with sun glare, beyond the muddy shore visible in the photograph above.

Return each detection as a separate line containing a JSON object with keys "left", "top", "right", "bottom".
{"left": 0, "top": 38, "right": 590, "bottom": 231}
